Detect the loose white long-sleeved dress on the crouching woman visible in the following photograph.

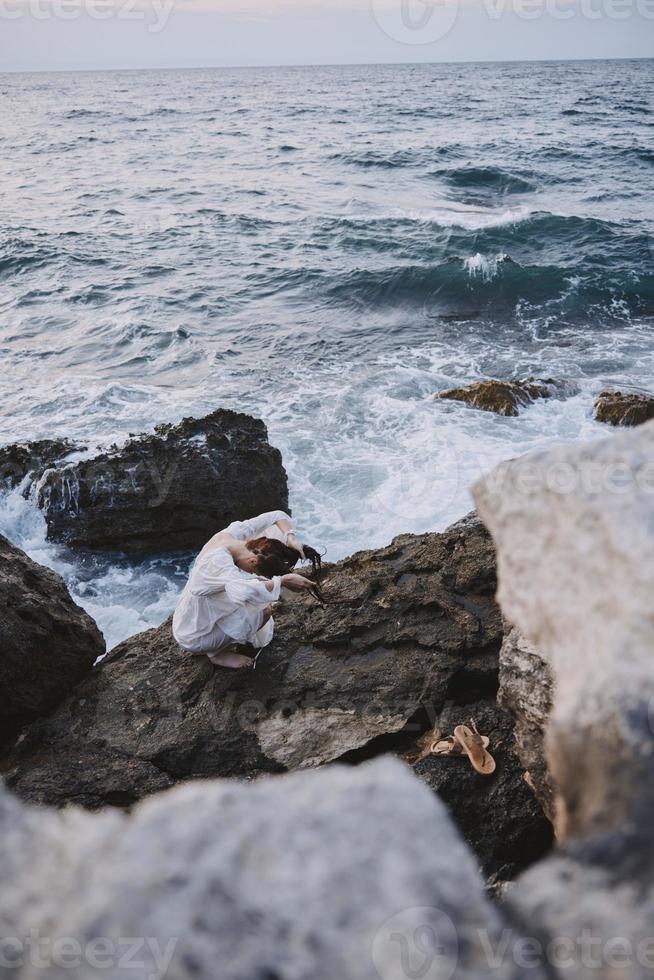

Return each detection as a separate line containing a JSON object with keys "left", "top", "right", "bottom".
{"left": 173, "top": 510, "right": 291, "bottom": 659}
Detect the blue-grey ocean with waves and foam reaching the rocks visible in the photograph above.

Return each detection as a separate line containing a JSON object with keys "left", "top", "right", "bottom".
{"left": 0, "top": 60, "right": 654, "bottom": 645}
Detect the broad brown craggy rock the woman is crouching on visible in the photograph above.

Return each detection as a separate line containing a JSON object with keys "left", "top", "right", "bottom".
{"left": 3, "top": 518, "right": 542, "bottom": 876}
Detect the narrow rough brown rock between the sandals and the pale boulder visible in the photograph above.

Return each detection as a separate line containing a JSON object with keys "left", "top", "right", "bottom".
{"left": 498, "top": 628, "right": 554, "bottom": 821}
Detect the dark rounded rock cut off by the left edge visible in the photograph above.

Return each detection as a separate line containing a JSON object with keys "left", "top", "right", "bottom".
{"left": 0, "top": 535, "right": 105, "bottom": 744}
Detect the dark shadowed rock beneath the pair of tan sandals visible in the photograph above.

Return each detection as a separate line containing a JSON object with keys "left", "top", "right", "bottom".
{"left": 415, "top": 701, "right": 553, "bottom": 881}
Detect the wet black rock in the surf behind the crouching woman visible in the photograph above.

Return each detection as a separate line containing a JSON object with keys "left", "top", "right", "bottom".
{"left": 30, "top": 410, "right": 288, "bottom": 554}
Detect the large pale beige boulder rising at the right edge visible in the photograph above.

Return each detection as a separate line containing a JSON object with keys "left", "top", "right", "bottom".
{"left": 475, "top": 424, "right": 654, "bottom": 839}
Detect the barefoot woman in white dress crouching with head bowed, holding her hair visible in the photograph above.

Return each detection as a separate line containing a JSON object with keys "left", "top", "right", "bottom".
{"left": 173, "top": 510, "right": 315, "bottom": 669}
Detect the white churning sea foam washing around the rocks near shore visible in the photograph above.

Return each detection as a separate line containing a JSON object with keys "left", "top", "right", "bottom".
{"left": 0, "top": 326, "right": 654, "bottom": 646}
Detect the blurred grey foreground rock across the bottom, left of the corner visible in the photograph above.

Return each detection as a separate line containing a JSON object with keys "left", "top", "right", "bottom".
{"left": 0, "top": 760, "right": 532, "bottom": 980}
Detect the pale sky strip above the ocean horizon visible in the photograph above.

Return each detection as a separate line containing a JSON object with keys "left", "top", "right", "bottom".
{"left": 0, "top": 0, "right": 654, "bottom": 71}
